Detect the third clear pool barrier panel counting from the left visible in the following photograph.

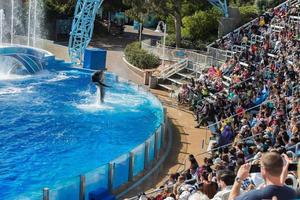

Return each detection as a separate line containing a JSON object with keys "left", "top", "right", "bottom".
{"left": 113, "top": 154, "right": 129, "bottom": 189}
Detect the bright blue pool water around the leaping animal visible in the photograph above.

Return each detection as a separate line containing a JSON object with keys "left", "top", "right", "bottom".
{"left": 0, "top": 69, "right": 163, "bottom": 199}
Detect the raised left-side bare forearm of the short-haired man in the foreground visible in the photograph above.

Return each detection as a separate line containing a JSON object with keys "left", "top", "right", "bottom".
{"left": 228, "top": 163, "right": 251, "bottom": 200}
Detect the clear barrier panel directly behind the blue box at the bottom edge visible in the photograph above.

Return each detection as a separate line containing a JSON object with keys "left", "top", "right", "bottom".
{"left": 85, "top": 164, "right": 109, "bottom": 199}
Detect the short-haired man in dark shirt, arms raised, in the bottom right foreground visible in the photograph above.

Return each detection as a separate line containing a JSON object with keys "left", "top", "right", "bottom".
{"left": 229, "top": 152, "right": 296, "bottom": 200}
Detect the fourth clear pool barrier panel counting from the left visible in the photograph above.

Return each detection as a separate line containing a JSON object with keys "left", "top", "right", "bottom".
{"left": 132, "top": 143, "right": 145, "bottom": 176}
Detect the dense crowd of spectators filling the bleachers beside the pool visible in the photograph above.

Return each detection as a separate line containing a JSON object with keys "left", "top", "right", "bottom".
{"left": 140, "top": 2, "right": 300, "bottom": 200}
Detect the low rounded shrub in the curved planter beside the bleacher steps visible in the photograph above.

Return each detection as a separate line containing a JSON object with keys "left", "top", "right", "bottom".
{"left": 124, "top": 42, "right": 160, "bottom": 69}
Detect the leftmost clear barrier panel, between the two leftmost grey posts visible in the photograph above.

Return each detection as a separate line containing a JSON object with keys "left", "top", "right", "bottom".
{"left": 49, "top": 176, "right": 80, "bottom": 200}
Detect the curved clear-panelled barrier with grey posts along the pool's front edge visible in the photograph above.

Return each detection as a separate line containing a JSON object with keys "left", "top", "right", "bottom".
{"left": 43, "top": 123, "right": 165, "bottom": 200}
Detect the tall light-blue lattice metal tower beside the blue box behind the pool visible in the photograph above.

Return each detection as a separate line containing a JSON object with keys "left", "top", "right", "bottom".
{"left": 69, "top": 0, "right": 104, "bottom": 64}
